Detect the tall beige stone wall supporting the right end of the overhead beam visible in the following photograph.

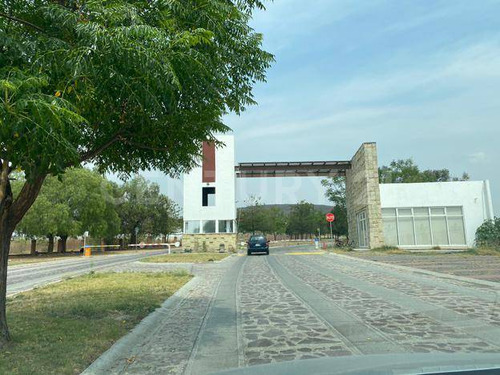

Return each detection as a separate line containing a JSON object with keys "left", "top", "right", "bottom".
{"left": 346, "top": 143, "right": 384, "bottom": 249}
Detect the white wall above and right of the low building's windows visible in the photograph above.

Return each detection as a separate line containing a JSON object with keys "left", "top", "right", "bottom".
{"left": 380, "top": 181, "right": 493, "bottom": 246}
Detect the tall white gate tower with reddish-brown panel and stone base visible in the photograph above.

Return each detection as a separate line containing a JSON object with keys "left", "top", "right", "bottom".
{"left": 183, "top": 135, "right": 236, "bottom": 251}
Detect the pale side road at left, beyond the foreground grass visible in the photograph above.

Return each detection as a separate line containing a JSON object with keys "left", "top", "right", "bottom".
{"left": 7, "top": 250, "right": 166, "bottom": 295}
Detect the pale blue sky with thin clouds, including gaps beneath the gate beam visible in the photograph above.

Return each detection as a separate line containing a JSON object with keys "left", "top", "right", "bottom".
{"left": 141, "top": 0, "right": 500, "bottom": 216}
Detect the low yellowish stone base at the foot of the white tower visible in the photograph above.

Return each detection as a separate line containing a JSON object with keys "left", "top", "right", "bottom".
{"left": 182, "top": 233, "right": 237, "bottom": 253}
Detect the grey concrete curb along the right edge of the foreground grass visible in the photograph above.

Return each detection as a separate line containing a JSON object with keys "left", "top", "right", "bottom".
{"left": 82, "top": 277, "right": 201, "bottom": 375}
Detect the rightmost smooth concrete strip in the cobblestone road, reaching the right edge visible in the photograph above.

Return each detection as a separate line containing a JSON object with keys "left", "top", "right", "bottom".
{"left": 303, "top": 259, "right": 500, "bottom": 348}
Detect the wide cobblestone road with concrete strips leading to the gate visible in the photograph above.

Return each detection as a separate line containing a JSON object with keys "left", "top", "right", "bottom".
{"left": 85, "top": 247, "right": 500, "bottom": 374}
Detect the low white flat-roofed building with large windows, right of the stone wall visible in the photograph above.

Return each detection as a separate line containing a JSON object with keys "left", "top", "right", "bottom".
{"left": 380, "top": 181, "right": 493, "bottom": 248}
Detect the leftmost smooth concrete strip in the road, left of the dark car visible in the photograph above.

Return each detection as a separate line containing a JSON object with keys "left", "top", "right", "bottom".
{"left": 184, "top": 258, "right": 246, "bottom": 375}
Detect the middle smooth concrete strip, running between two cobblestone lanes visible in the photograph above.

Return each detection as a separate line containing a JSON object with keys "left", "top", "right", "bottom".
{"left": 269, "top": 257, "right": 405, "bottom": 354}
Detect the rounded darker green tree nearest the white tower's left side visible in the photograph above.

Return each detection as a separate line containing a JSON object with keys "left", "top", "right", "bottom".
{"left": 116, "top": 176, "right": 181, "bottom": 243}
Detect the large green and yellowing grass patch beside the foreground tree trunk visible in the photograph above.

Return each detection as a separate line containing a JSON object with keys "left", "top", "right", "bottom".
{"left": 0, "top": 273, "right": 191, "bottom": 375}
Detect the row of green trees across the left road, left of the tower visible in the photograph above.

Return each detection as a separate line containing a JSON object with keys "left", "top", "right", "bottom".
{"left": 12, "top": 168, "right": 182, "bottom": 253}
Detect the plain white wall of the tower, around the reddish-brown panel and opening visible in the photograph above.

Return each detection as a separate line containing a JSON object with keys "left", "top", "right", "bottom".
{"left": 183, "top": 135, "right": 236, "bottom": 226}
